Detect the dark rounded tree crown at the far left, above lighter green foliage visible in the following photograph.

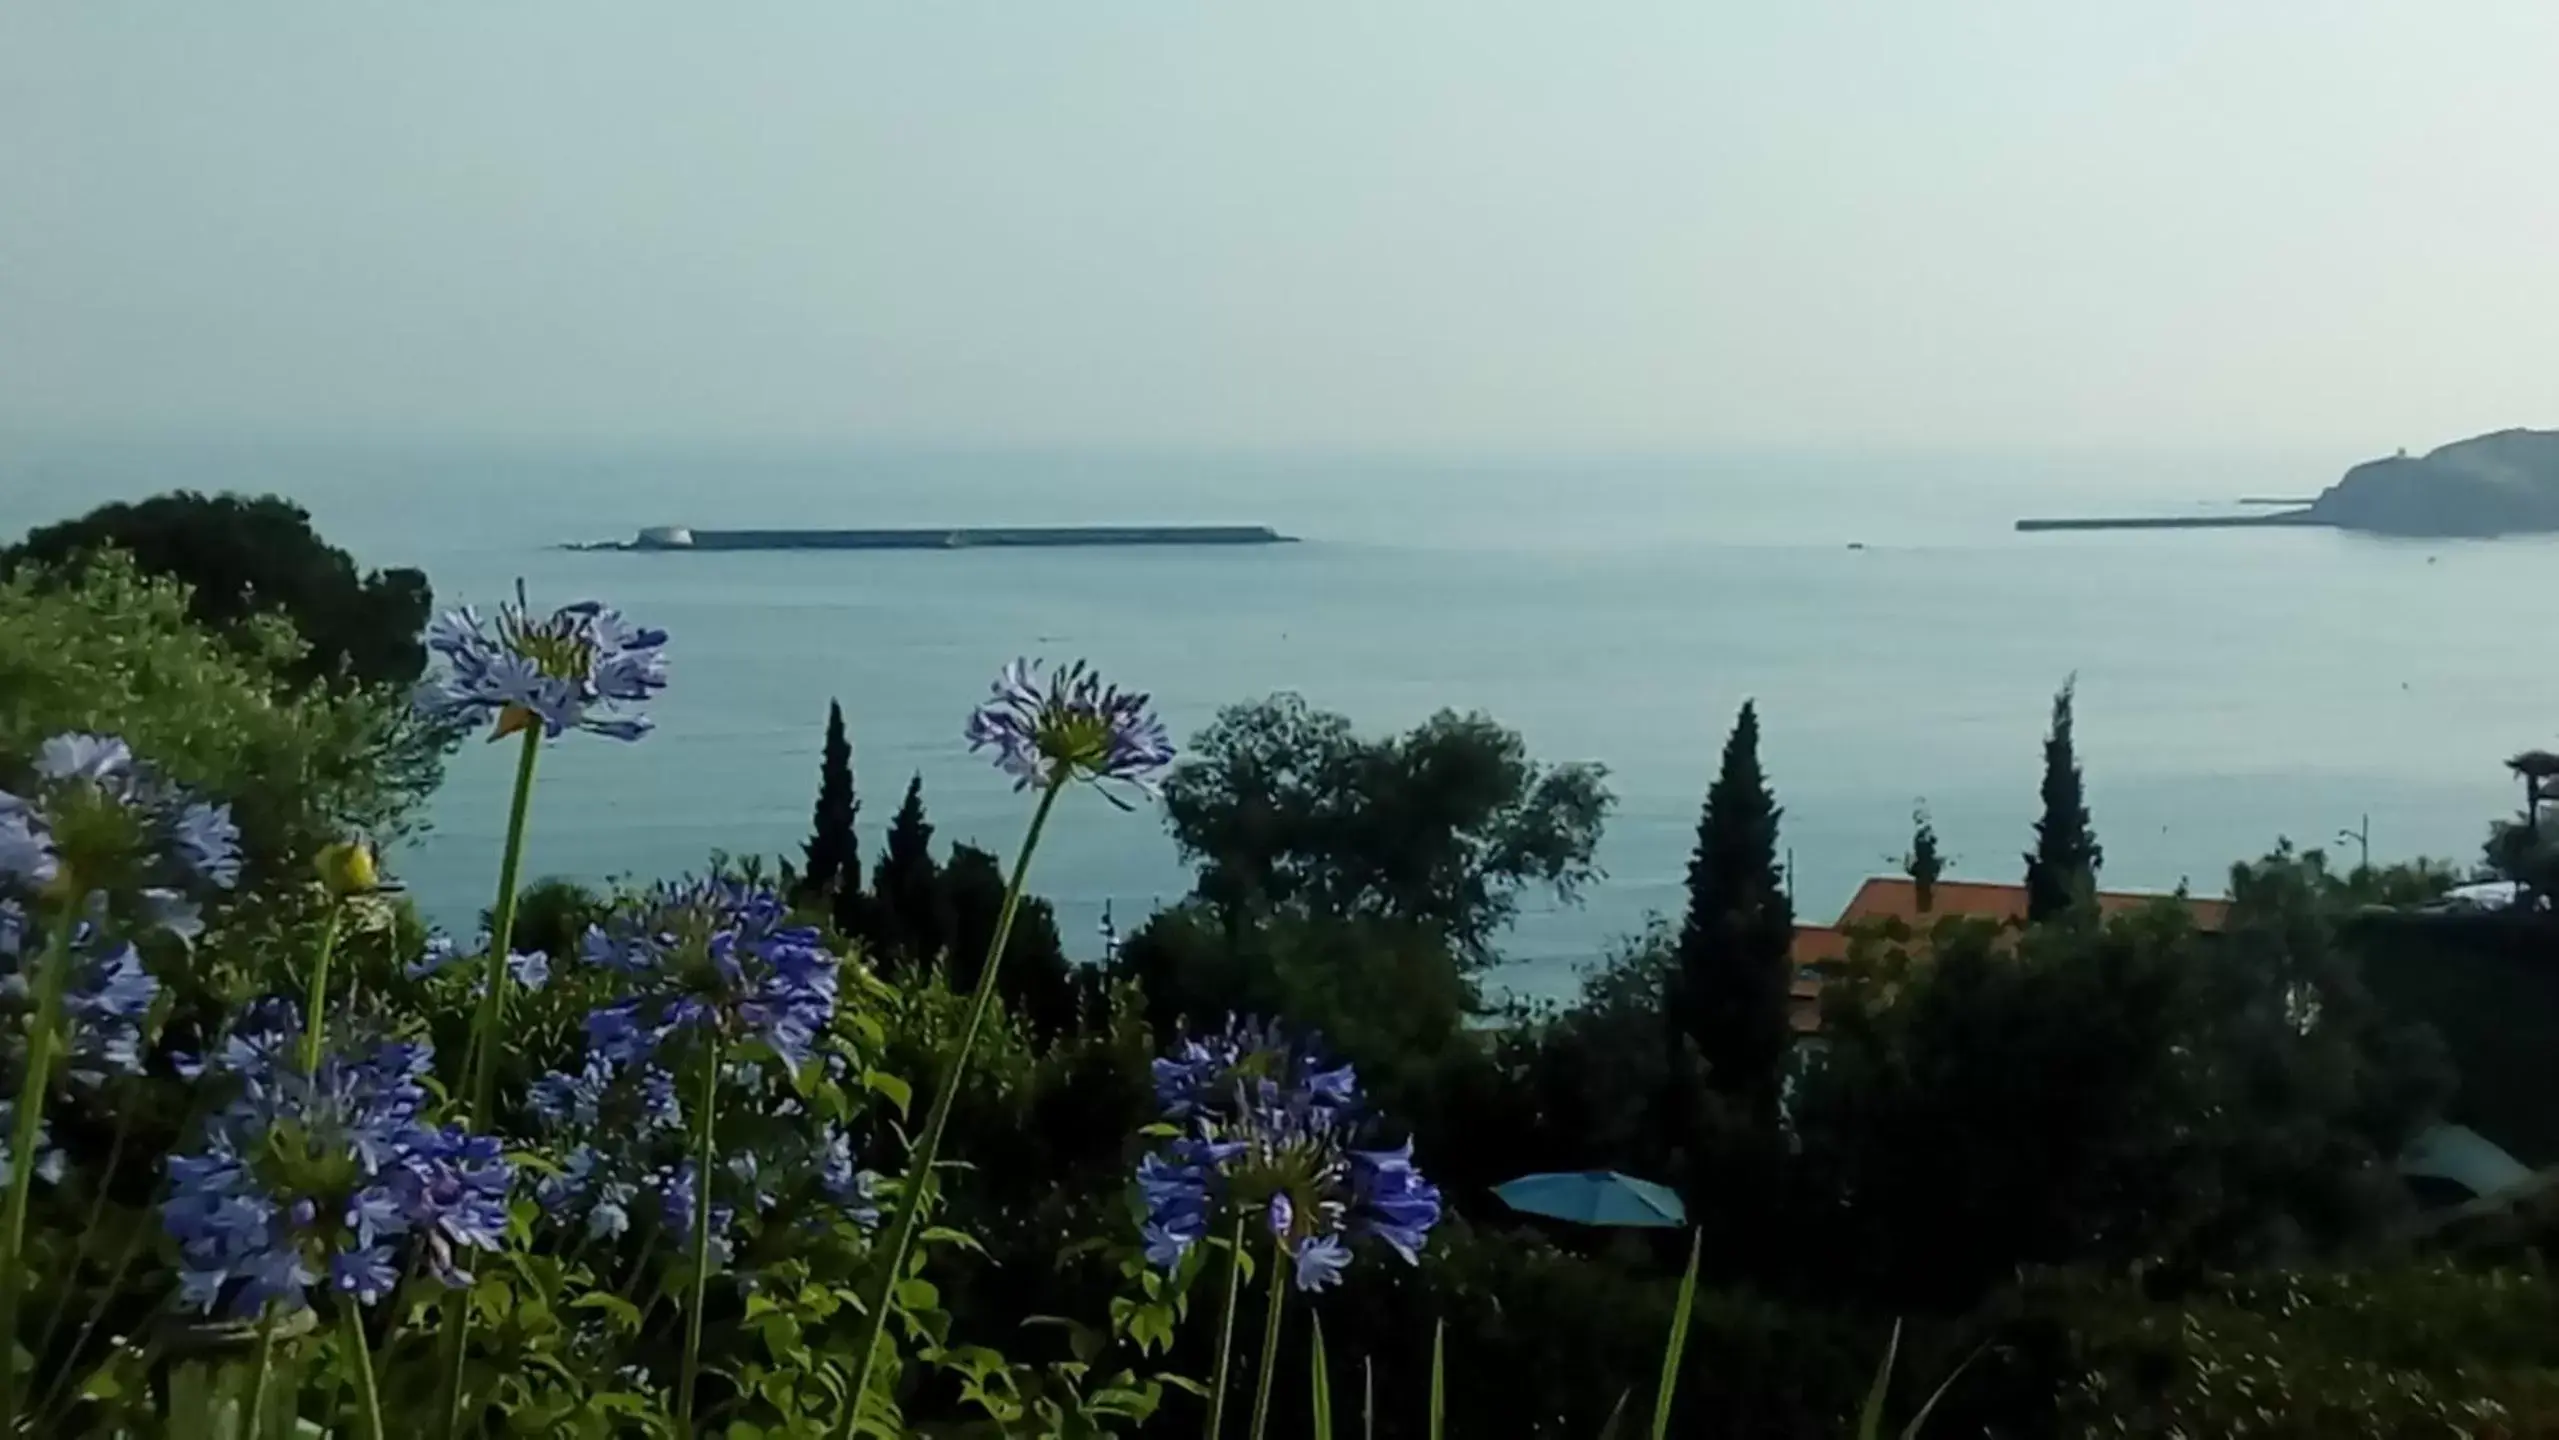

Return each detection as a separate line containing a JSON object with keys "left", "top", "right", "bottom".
{"left": 0, "top": 491, "right": 435, "bottom": 685}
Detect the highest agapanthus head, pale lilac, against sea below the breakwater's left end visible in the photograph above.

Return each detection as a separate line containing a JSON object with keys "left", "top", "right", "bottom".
{"left": 417, "top": 586, "right": 665, "bottom": 739}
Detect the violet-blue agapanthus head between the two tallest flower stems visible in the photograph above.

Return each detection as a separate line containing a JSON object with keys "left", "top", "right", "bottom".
{"left": 578, "top": 877, "right": 837, "bottom": 1067}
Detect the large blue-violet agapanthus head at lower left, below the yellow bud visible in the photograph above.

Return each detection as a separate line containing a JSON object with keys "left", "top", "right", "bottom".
{"left": 161, "top": 1003, "right": 512, "bottom": 1315}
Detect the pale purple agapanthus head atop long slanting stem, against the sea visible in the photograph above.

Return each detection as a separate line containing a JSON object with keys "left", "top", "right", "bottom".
{"left": 965, "top": 660, "right": 1172, "bottom": 803}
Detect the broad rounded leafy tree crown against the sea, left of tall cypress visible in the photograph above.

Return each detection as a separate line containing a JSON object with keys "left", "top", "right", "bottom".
{"left": 1164, "top": 693, "right": 1610, "bottom": 964}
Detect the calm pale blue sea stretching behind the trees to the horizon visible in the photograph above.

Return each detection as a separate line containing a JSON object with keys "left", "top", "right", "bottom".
{"left": 0, "top": 440, "right": 2559, "bottom": 992}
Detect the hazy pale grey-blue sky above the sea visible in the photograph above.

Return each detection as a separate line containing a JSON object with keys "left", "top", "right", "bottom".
{"left": 0, "top": 0, "right": 2559, "bottom": 450}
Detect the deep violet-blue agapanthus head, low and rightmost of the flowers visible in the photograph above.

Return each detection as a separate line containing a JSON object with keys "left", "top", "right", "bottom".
{"left": 1136, "top": 1021, "right": 1441, "bottom": 1292}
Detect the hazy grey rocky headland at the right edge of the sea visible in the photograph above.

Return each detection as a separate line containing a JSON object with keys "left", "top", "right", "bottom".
{"left": 2306, "top": 430, "right": 2559, "bottom": 535}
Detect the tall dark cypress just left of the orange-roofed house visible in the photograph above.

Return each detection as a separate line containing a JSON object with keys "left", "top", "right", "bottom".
{"left": 1674, "top": 703, "right": 1794, "bottom": 1128}
